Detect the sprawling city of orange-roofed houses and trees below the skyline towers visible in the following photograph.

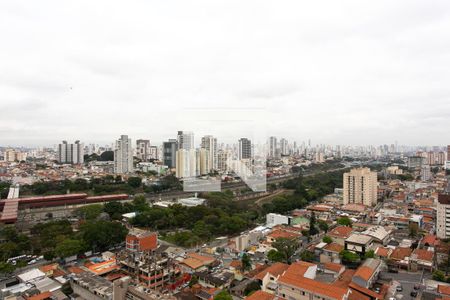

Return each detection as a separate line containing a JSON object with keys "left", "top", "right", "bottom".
{"left": 0, "top": 141, "right": 450, "bottom": 300}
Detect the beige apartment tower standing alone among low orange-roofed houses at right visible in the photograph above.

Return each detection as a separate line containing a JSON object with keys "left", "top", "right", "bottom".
{"left": 343, "top": 168, "right": 378, "bottom": 206}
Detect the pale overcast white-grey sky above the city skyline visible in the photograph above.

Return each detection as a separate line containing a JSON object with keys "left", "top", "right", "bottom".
{"left": 0, "top": 0, "right": 450, "bottom": 146}
